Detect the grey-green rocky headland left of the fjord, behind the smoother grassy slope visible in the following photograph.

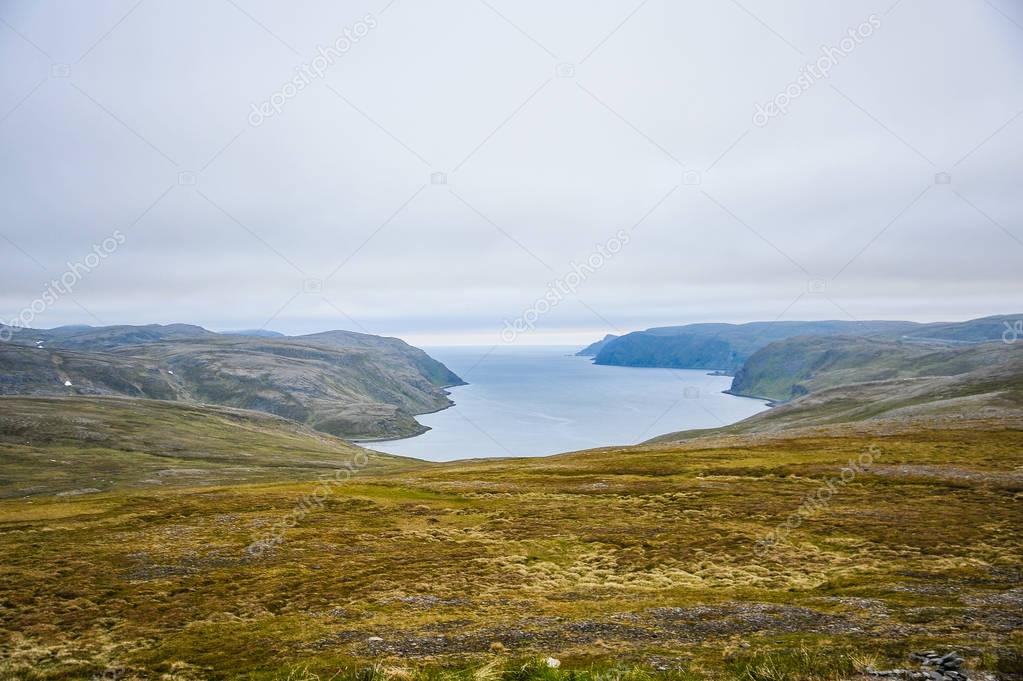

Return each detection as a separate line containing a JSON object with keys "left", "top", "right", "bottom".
{"left": 0, "top": 324, "right": 462, "bottom": 439}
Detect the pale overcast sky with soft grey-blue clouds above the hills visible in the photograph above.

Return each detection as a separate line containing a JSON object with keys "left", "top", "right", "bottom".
{"left": 0, "top": 0, "right": 1023, "bottom": 346}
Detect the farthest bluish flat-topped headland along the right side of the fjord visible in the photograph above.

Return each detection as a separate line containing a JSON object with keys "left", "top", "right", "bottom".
{"left": 584, "top": 315, "right": 1023, "bottom": 372}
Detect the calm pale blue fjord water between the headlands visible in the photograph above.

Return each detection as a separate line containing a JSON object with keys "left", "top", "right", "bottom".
{"left": 364, "top": 347, "right": 767, "bottom": 461}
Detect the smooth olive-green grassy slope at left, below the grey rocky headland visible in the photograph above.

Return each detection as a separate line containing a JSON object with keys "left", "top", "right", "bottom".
{"left": 0, "top": 397, "right": 419, "bottom": 498}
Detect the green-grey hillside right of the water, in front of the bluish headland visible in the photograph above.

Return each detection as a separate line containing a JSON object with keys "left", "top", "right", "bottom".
{"left": 651, "top": 336, "right": 1023, "bottom": 442}
